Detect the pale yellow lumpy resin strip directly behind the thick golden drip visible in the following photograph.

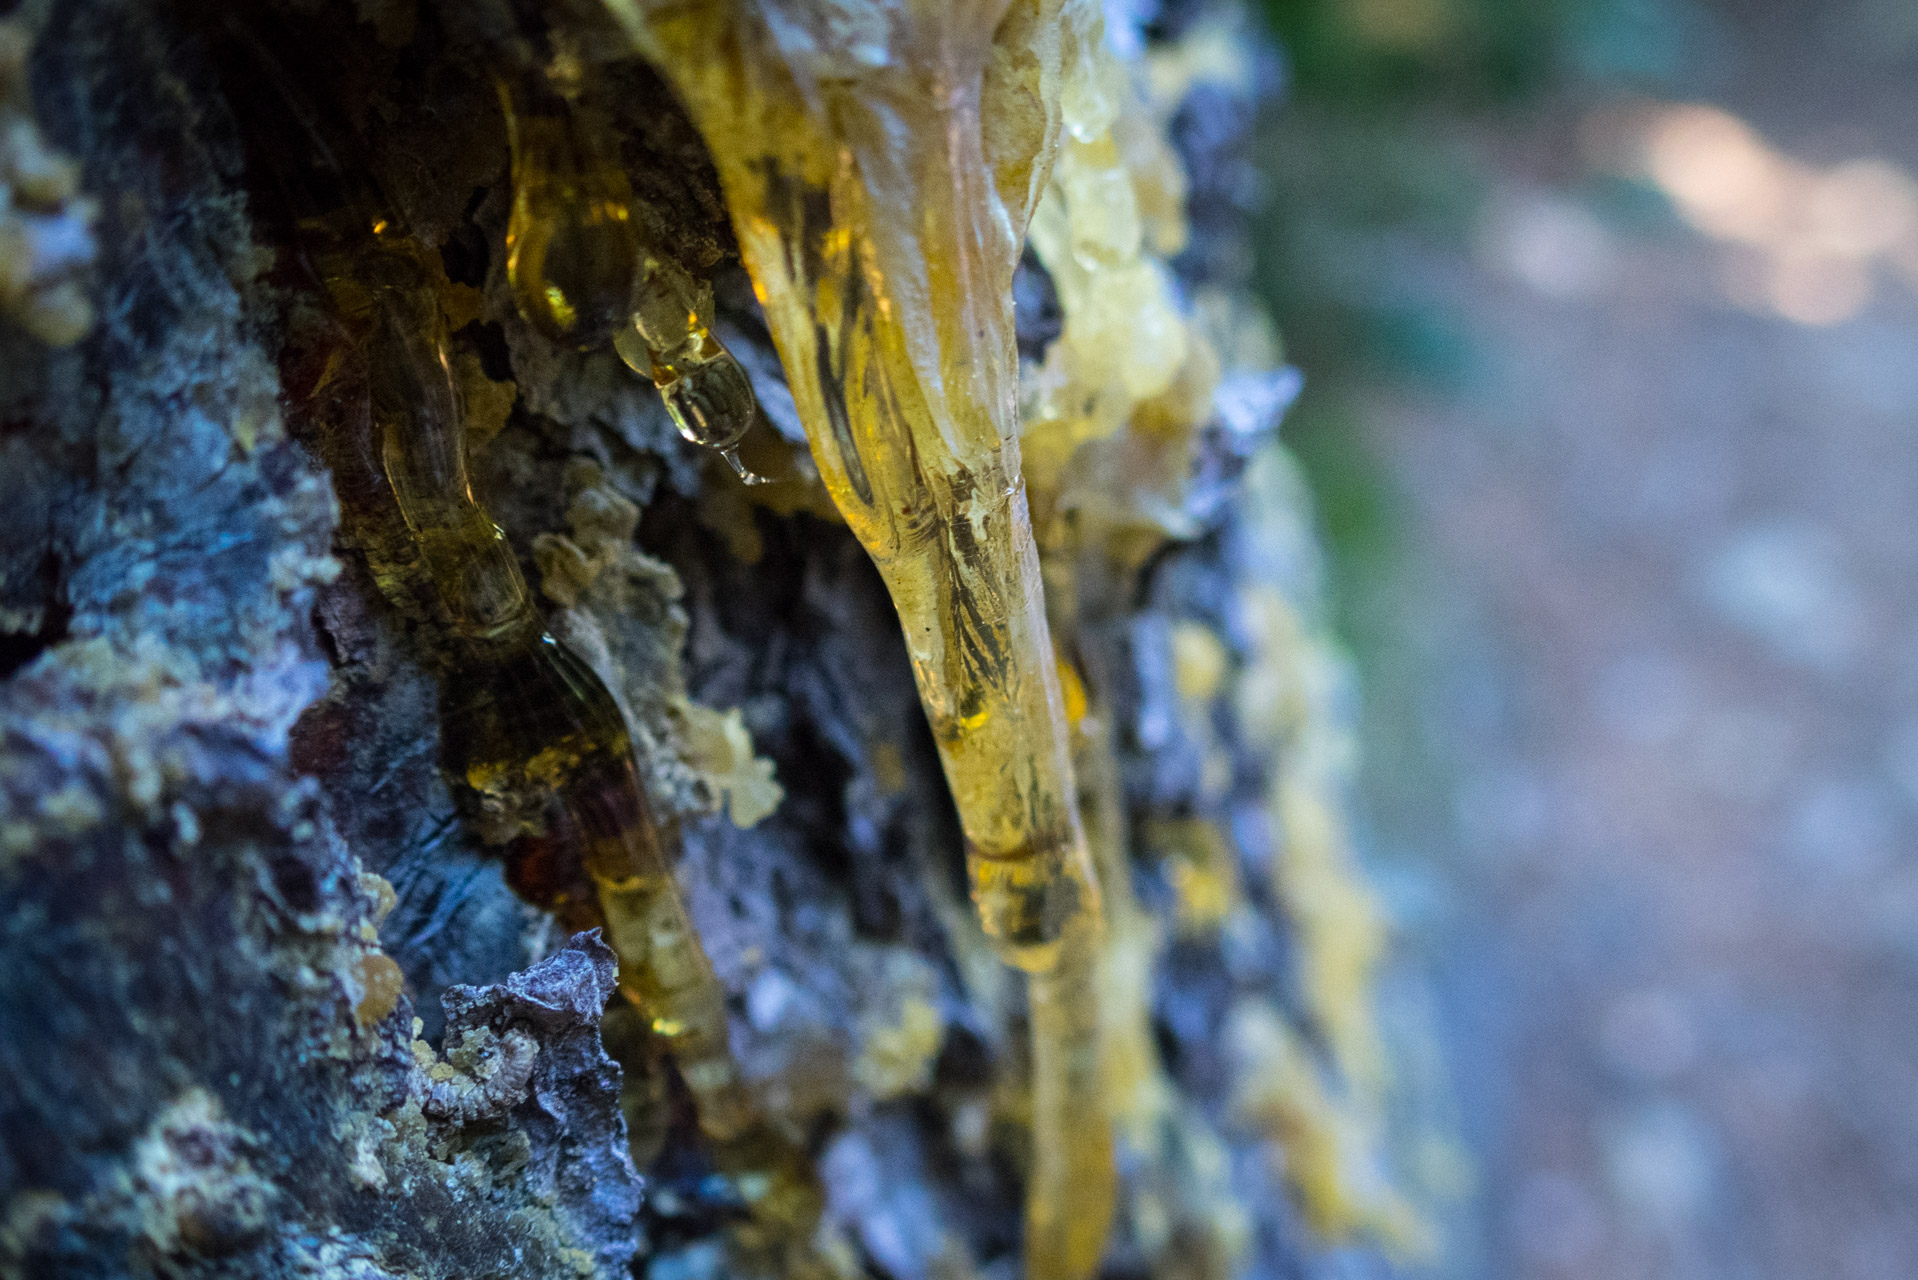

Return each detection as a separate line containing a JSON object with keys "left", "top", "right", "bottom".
{"left": 1022, "top": 13, "right": 1247, "bottom": 1280}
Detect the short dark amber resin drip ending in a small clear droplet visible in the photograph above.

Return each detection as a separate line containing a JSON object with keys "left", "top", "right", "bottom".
{"left": 499, "top": 61, "right": 765, "bottom": 484}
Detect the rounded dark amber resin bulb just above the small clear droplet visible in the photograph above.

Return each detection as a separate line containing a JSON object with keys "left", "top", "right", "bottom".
{"left": 499, "top": 77, "right": 639, "bottom": 349}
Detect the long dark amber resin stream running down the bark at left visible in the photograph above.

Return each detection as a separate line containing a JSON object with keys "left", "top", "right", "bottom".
{"left": 322, "top": 219, "right": 754, "bottom": 1140}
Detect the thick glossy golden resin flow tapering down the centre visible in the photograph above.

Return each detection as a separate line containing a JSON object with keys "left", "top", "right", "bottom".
{"left": 612, "top": 0, "right": 1114, "bottom": 1280}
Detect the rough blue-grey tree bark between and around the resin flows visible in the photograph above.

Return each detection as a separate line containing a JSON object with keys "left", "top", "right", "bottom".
{"left": 0, "top": 0, "right": 1411, "bottom": 1280}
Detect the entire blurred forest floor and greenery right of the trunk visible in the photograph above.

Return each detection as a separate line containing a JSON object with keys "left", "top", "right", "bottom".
{"left": 1256, "top": 0, "right": 1918, "bottom": 1280}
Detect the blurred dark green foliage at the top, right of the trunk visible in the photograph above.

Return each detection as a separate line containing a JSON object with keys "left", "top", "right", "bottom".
{"left": 1256, "top": 0, "right": 1709, "bottom": 637}
